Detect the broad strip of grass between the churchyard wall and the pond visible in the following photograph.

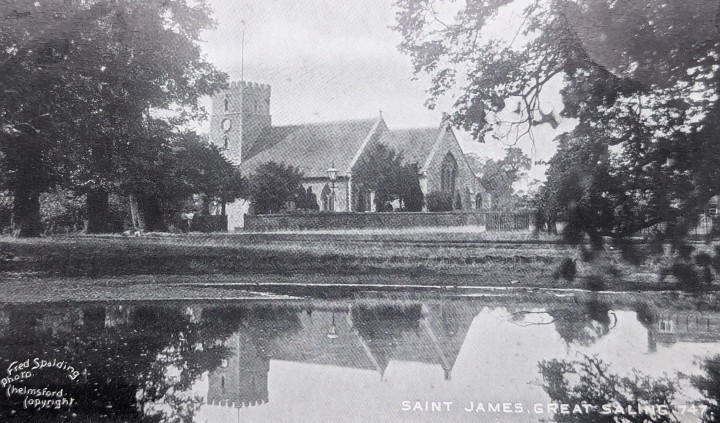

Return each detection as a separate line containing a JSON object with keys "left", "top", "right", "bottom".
{"left": 0, "top": 231, "right": 708, "bottom": 289}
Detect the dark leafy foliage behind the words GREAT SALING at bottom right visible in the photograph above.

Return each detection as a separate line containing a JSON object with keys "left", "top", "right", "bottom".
{"left": 539, "top": 356, "right": 678, "bottom": 423}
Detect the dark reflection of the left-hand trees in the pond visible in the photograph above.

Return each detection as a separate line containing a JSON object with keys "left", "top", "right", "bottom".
{"left": 0, "top": 306, "right": 256, "bottom": 422}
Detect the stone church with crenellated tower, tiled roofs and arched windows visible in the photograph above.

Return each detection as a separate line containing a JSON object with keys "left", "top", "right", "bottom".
{"left": 210, "top": 81, "right": 491, "bottom": 230}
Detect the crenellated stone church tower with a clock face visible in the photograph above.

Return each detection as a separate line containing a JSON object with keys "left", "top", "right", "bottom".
{"left": 210, "top": 81, "right": 271, "bottom": 165}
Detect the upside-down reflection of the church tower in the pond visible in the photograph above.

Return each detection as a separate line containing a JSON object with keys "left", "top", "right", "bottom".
{"left": 207, "top": 326, "right": 270, "bottom": 407}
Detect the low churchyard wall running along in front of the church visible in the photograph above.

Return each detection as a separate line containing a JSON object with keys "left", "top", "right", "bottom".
{"left": 245, "top": 212, "right": 530, "bottom": 232}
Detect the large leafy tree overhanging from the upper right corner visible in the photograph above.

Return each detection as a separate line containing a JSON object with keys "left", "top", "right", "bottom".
{"left": 396, "top": 0, "right": 720, "bottom": 241}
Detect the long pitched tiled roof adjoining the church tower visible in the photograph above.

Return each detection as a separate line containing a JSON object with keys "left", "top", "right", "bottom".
{"left": 240, "top": 118, "right": 384, "bottom": 178}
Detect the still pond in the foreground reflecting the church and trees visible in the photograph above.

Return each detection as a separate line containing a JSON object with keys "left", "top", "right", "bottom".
{"left": 0, "top": 292, "right": 720, "bottom": 422}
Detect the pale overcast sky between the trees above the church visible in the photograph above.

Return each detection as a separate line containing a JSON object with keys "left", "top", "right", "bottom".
{"left": 204, "top": 0, "right": 561, "bottom": 186}
